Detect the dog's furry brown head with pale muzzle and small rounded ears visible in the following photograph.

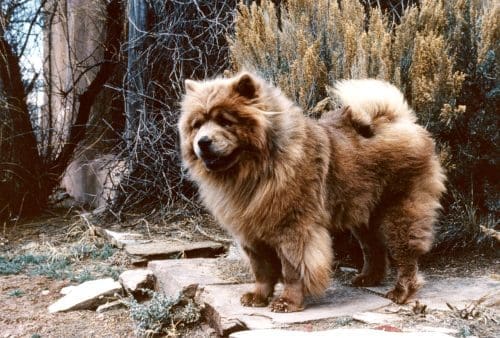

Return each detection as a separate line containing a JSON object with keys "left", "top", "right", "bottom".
{"left": 179, "top": 73, "right": 278, "bottom": 172}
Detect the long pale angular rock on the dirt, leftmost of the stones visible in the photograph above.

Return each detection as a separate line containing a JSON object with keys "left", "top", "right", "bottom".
{"left": 49, "top": 278, "right": 122, "bottom": 313}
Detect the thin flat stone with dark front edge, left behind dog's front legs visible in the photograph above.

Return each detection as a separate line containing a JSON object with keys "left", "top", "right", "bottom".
{"left": 125, "top": 241, "right": 226, "bottom": 260}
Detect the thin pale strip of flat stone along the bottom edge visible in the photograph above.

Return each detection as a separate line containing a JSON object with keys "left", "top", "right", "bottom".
{"left": 229, "top": 329, "right": 453, "bottom": 338}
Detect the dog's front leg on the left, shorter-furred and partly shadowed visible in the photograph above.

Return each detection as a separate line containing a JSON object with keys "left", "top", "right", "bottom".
{"left": 240, "top": 243, "right": 281, "bottom": 307}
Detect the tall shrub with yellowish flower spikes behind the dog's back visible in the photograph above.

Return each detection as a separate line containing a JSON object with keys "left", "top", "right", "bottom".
{"left": 229, "top": 0, "right": 500, "bottom": 248}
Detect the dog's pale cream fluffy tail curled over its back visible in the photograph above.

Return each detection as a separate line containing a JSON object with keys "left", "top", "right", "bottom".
{"left": 333, "top": 79, "right": 417, "bottom": 136}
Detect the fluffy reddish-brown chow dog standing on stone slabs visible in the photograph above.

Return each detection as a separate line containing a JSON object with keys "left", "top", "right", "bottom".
{"left": 179, "top": 73, "right": 445, "bottom": 312}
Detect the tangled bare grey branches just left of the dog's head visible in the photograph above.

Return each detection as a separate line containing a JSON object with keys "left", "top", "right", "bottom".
{"left": 117, "top": 0, "right": 236, "bottom": 214}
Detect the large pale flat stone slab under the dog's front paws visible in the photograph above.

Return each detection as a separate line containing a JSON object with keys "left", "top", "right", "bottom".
{"left": 148, "top": 259, "right": 391, "bottom": 335}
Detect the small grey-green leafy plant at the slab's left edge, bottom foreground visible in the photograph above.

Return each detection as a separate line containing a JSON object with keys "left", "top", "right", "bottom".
{"left": 127, "top": 290, "right": 201, "bottom": 337}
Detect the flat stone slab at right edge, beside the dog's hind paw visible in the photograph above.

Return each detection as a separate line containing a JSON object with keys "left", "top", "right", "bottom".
{"left": 367, "top": 277, "right": 500, "bottom": 310}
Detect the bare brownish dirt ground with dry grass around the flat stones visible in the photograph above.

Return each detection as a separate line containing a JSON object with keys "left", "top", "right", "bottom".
{"left": 0, "top": 213, "right": 500, "bottom": 338}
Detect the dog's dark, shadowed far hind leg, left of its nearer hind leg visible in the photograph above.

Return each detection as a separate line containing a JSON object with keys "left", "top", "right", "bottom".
{"left": 351, "top": 222, "right": 387, "bottom": 286}
